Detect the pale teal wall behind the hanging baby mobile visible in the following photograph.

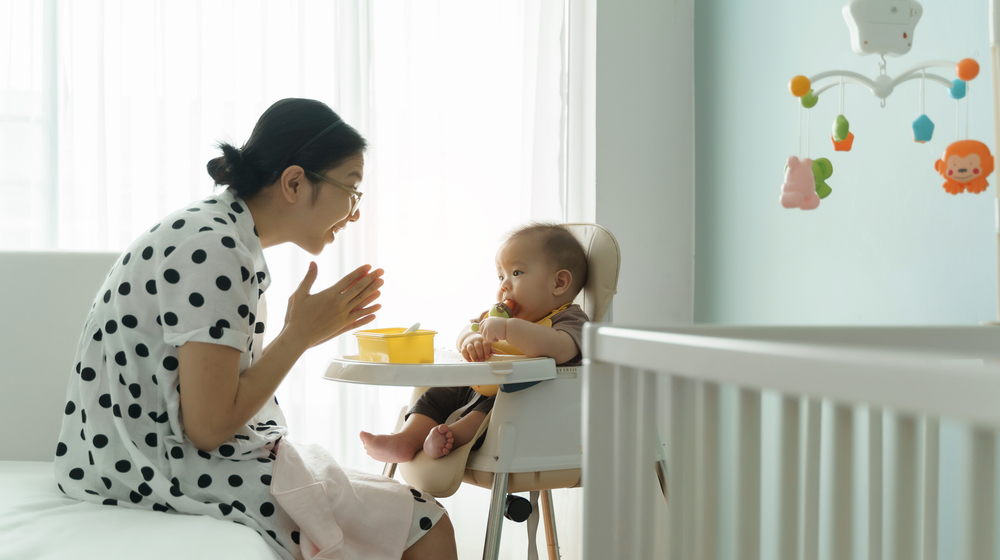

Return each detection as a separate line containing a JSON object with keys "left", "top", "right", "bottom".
{"left": 695, "top": 0, "right": 997, "bottom": 325}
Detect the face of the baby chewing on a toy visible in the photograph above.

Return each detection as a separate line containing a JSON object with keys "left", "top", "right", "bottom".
{"left": 496, "top": 235, "right": 557, "bottom": 322}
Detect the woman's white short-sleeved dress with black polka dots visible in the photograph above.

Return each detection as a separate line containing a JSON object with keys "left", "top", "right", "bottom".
{"left": 55, "top": 190, "right": 440, "bottom": 559}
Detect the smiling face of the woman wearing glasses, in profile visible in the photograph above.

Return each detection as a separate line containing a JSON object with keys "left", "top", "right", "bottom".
{"left": 297, "top": 154, "right": 365, "bottom": 255}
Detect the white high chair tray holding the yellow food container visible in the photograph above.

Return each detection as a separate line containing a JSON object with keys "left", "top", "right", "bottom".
{"left": 323, "top": 348, "right": 556, "bottom": 387}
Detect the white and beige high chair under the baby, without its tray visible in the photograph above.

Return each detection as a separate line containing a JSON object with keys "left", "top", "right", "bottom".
{"left": 384, "top": 224, "right": 621, "bottom": 560}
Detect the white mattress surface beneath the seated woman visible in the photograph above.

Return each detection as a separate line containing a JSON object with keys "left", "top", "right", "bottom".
{"left": 0, "top": 461, "right": 280, "bottom": 560}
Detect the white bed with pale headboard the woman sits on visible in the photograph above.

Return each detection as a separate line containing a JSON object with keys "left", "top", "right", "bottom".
{"left": 0, "top": 251, "right": 280, "bottom": 560}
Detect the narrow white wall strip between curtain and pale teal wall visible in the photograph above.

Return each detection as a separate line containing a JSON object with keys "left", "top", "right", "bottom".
{"left": 596, "top": 0, "right": 695, "bottom": 326}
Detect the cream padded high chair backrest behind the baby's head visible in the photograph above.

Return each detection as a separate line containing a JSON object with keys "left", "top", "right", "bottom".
{"left": 565, "top": 224, "right": 621, "bottom": 323}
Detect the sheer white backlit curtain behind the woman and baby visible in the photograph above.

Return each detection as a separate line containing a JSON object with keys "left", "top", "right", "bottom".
{"left": 0, "top": 0, "right": 579, "bottom": 558}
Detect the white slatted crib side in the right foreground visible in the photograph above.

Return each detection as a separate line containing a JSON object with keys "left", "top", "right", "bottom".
{"left": 583, "top": 324, "right": 1000, "bottom": 560}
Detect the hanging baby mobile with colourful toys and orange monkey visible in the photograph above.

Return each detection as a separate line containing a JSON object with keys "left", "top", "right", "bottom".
{"left": 779, "top": 0, "right": 993, "bottom": 210}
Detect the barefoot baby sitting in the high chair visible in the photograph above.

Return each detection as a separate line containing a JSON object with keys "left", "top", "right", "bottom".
{"left": 361, "top": 224, "right": 589, "bottom": 463}
